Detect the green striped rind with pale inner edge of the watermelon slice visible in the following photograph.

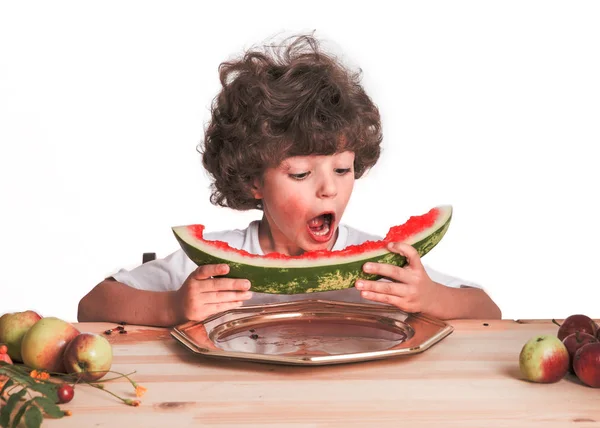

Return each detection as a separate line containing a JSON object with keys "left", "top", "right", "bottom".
{"left": 172, "top": 206, "right": 452, "bottom": 294}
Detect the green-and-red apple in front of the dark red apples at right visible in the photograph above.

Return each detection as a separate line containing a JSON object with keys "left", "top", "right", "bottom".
{"left": 519, "top": 335, "right": 569, "bottom": 383}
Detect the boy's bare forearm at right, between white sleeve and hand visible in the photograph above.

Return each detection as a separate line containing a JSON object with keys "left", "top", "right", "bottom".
{"left": 430, "top": 283, "right": 502, "bottom": 319}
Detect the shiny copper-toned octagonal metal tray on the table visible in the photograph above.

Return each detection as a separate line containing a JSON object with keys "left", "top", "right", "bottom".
{"left": 170, "top": 300, "right": 454, "bottom": 366}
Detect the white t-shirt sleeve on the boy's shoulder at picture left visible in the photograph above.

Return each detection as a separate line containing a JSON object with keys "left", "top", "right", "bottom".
{"left": 111, "top": 249, "right": 197, "bottom": 291}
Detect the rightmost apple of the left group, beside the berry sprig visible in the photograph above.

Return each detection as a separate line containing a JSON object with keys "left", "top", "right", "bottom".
{"left": 63, "top": 333, "right": 112, "bottom": 382}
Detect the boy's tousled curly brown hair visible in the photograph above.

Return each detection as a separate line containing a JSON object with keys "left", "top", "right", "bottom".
{"left": 198, "top": 35, "right": 382, "bottom": 210}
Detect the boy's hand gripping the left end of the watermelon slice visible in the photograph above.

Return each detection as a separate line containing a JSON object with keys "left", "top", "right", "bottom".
{"left": 175, "top": 264, "right": 252, "bottom": 321}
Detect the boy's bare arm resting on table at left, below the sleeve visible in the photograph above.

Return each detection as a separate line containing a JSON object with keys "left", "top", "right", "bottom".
{"left": 77, "top": 278, "right": 183, "bottom": 327}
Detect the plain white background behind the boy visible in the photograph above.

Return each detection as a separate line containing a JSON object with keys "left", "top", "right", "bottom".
{"left": 0, "top": 0, "right": 600, "bottom": 321}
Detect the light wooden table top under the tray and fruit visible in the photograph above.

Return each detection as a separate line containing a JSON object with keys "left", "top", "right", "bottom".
{"left": 43, "top": 320, "right": 600, "bottom": 428}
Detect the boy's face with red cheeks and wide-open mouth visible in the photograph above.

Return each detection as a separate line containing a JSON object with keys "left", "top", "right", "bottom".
{"left": 253, "top": 152, "right": 354, "bottom": 255}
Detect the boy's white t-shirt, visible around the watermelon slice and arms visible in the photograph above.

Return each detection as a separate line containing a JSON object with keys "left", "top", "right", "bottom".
{"left": 112, "top": 220, "right": 481, "bottom": 305}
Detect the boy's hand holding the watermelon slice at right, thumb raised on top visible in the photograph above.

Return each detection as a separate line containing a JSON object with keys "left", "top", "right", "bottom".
{"left": 356, "top": 242, "right": 443, "bottom": 312}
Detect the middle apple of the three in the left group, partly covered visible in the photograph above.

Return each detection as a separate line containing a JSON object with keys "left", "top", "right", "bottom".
{"left": 21, "top": 317, "right": 79, "bottom": 373}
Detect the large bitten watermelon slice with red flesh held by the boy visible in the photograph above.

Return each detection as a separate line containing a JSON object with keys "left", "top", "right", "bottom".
{"left": 172, "top": 205, "right": 452, "bottom": 294}
